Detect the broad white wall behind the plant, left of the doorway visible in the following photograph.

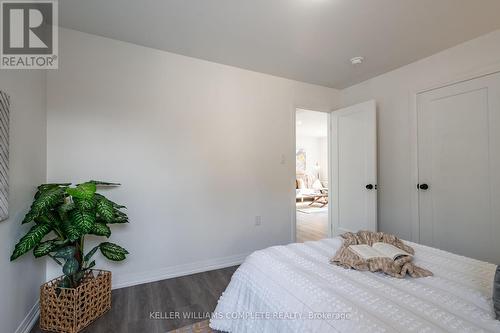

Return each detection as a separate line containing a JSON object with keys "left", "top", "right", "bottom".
{"left": 47, "top": 29, "right": 339, "bottom": 286}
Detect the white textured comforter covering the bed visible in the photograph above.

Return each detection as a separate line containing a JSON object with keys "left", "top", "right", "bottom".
{"left": 210, "top": 238, "right": 500, "bottom": 333}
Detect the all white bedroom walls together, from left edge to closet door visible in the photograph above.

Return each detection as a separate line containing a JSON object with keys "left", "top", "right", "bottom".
{"left": 0, "top": 18, "right": 500, "bottom": 332}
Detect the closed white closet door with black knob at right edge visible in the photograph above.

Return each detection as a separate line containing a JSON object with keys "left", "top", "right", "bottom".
{"left": 416, "top": 74, "right": 500, "bottom": 264}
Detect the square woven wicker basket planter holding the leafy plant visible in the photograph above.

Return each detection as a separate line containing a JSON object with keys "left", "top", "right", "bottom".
{"left": 40, "top": 270, "right": 111, "bottom": 333}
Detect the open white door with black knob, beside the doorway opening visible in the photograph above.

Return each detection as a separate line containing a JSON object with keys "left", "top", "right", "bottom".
{"left": 330, "top": 101, "right": 377, "bottom": 235}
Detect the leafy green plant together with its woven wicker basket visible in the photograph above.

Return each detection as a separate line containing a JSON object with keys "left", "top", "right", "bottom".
{"left": 10, "top": 181, "right": 128, "bottom": 333}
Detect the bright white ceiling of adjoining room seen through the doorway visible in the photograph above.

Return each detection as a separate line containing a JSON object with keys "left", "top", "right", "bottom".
{"left": 295, "top": 109, "right": 328, "bottom": 138}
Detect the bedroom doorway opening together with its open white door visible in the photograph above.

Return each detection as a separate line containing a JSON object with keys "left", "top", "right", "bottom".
{"left": 292, "top": 100, "right": 379, "bottom": 242}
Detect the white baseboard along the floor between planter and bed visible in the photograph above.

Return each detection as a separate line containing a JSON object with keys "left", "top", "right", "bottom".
{"left": 113, "top": 253, "right": 250, "bottom": 289}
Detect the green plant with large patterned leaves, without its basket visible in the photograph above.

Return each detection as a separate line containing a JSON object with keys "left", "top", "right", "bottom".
{"left": 10, "top": 180, "right": 128, "bottom": 288}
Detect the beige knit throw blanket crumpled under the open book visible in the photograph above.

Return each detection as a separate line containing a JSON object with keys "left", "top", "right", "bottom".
{"left": 330, "top": 231, "right": 432, "bottom": 278}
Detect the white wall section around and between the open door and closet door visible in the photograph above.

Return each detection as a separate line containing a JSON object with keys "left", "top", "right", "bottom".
{"left": 342, "top": 30, "right": 500, "bottom": 239}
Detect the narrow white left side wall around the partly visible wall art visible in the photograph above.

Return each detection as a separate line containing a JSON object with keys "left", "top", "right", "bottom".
{"left": 0, "top": 70, "right": 46, "bottom": 333}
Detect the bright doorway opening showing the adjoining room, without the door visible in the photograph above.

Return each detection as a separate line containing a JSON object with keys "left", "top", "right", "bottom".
{"left": 295, "top": 109, "right": 330, "bottom": 243}
